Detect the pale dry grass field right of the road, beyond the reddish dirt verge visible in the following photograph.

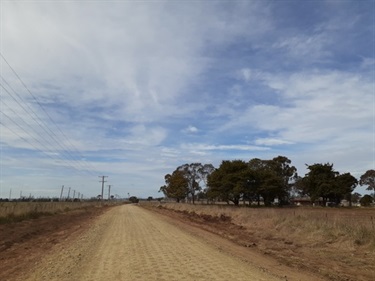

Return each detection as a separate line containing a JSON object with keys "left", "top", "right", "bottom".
{"left": 159, "top": 203, "right": 375, "bottom": 247}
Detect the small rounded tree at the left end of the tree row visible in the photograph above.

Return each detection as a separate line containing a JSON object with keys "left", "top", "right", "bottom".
{"left": 159, "top": 170, "right": 189, "bottom": 202}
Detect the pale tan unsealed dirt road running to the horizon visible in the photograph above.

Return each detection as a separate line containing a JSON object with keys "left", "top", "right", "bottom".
{"left": 15, "top": 205, "right": 317, "bottom": 281}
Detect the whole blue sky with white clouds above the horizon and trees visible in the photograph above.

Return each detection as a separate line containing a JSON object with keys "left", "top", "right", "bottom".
{"left": 0, "top": 1, "right": 375, "bottom": 197}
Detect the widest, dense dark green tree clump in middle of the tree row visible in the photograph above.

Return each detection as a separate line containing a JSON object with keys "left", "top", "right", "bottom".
{"left": 207, "top": 156, "right": 297, "bottom": 206}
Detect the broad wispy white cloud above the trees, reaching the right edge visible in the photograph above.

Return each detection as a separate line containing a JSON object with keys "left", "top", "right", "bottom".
{"left": 222, "top": 68, "right": 373, "bottom": 143}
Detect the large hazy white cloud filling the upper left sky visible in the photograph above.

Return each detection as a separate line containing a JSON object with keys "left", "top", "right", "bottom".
{"left": 2, "top": 2, "right": 267, "bottom": 121}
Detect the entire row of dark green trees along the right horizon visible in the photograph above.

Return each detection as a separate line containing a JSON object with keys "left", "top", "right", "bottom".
{"left": 159, "top": 156, "right": 375, "bottom": 206}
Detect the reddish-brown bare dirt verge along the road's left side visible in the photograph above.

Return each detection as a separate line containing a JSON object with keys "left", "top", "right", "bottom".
{"left": 0, "top": 207, "right": 108, "bottom": 280}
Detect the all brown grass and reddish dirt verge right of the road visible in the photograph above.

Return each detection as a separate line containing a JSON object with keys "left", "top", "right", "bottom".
{"left": 144, "top": 203, "right": 375, "bottom": 280}
